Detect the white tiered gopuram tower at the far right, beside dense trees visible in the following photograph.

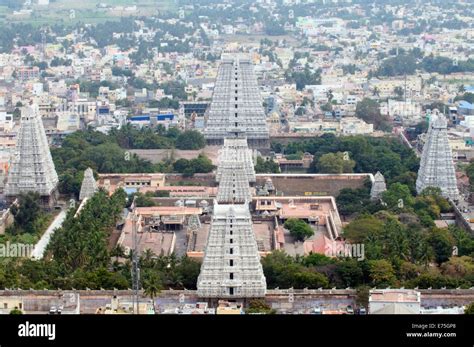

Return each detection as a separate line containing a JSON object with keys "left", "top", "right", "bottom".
{"left": 416, "top": 115, "right": 459, "bottom": 200}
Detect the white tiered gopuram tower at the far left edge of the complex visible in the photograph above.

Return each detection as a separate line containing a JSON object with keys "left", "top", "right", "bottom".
{"left": 5, "top": 105, "right": 58, "bottom": 203}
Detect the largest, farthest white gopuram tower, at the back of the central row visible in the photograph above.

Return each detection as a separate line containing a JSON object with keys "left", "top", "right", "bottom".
{"left": 204, "top": 55, "right": 269, "bottom": 148}
